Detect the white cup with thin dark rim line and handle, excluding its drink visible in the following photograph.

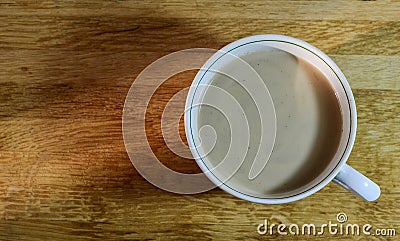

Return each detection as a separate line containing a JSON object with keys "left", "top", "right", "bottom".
{"left": 185, "top": 34, "right": 380, "bottom": 204}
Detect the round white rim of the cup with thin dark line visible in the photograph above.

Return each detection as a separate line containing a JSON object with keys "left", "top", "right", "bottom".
{"left": 184, "top": 34, "right": 357, "bottom": 204}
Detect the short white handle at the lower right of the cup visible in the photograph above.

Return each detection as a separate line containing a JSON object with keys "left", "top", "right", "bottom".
{"left": 333, "top": 164, "right": 381, "bottom": 202}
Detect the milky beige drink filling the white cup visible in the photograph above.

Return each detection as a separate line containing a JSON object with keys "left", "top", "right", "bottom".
{"left": 198, "top": 49, "right": 342, "bottom": 197}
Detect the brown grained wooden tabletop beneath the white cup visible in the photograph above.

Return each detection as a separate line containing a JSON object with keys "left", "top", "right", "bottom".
{"left": 0, "top": 0, "right": 400, "bottom": 240}
